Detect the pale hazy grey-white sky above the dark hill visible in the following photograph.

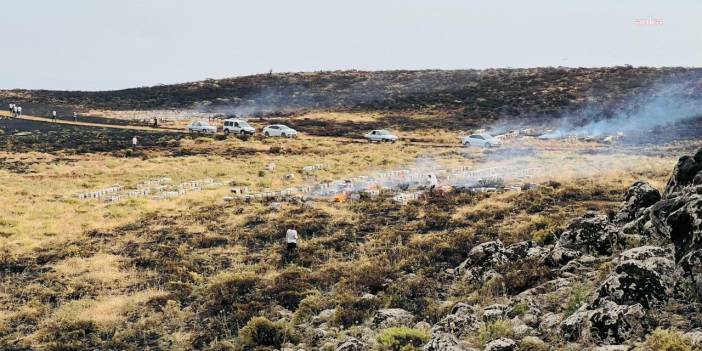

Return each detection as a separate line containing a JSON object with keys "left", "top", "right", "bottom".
{"left": 0, "top": 0, "right": 702, "bottom": 90}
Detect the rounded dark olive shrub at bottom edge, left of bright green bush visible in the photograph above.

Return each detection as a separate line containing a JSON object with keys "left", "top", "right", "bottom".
{"left": 239, "top": 317, "right": 293, "bottom": 348}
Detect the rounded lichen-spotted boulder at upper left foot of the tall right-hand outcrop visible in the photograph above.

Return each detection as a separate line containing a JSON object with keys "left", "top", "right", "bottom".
{"left": 557, "top": 212, "right": 619, "bottom": 255}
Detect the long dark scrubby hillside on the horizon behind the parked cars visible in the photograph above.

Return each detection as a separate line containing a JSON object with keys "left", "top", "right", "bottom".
{"left": 0, "top": 66, "right": 702, "bottom": 119}
